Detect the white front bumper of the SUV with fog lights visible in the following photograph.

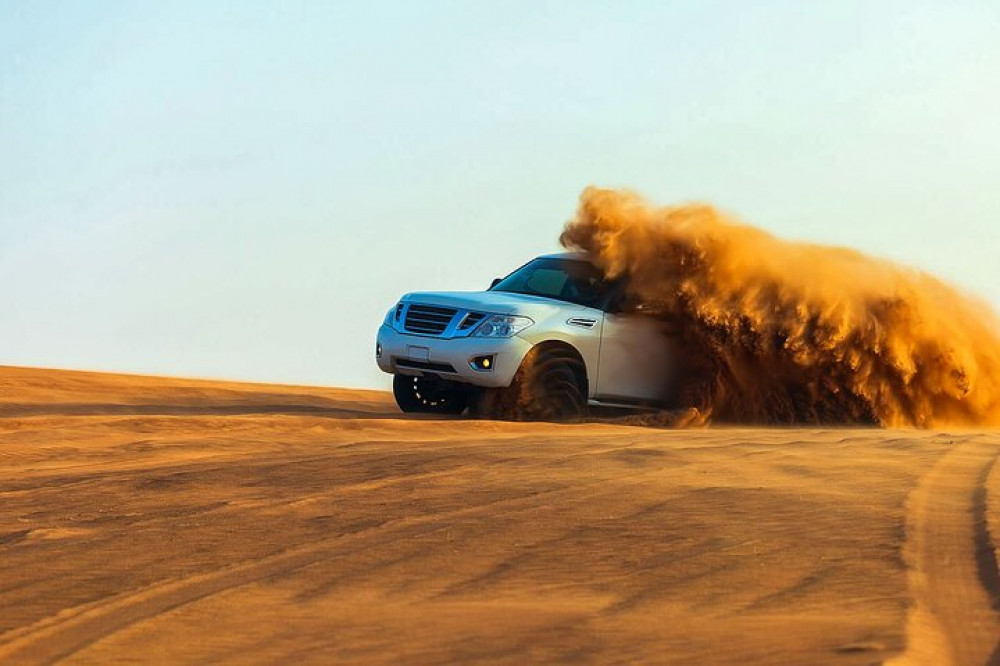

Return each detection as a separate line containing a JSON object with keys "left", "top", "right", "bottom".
{"left": 376, "top": 324, "right": 531, "bottom": 387}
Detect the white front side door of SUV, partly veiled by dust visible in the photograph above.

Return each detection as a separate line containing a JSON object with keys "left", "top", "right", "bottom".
{"left": 596, "top": 310, "right": 677, "bottom": 405}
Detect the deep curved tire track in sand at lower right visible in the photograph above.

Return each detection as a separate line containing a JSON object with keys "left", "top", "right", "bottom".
{"left": 887, "top": 441, "right": 1000, "bottom": 666}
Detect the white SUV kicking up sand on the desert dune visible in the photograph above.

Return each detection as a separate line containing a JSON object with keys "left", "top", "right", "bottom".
{"left": 375, "top": 253, "right": 676, "bottom": 420}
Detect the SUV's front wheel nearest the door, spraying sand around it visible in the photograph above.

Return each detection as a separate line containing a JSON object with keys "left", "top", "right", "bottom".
{"left": 470, "top": 345, "right": 587, "bottom": 421}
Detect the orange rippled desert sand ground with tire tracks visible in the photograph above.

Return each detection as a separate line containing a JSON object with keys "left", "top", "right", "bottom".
{"left": 0, "top": 367, "right": 1000, "bottom": 664}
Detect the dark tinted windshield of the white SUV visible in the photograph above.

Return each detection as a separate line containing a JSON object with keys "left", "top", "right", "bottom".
{"left": 490, "top": 259, "right": 609, "bottom": 308}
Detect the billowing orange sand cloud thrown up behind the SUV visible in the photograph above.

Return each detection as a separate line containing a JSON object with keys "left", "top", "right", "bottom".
{"left": 560, "top": 188, "right": 1000, "bottom": 427}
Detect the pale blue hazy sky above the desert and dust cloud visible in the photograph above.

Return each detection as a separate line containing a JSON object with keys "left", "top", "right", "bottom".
{"left": 0, "top": 0, "right": 1000, "bottom": 388}
